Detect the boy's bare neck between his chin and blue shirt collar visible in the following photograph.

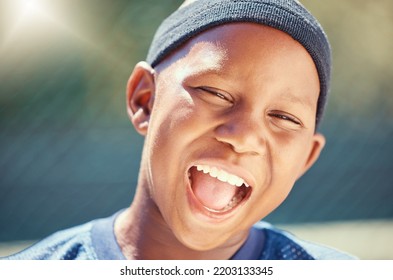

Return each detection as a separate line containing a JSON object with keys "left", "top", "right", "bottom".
{"left": 115, "top": 180, "right": 247, "bottom": 260}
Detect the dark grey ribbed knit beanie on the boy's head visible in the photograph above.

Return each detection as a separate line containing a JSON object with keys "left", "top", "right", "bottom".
{"left": 147, "top": 0, "right": 331, "bottom": 125}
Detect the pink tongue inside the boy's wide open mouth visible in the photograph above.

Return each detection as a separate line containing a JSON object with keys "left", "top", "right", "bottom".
{"left": 191, "top": 168, "right": 237, "bottom": 210}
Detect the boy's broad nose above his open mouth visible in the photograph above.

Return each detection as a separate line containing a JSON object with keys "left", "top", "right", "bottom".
{"left": 215, "top": 113, "right": 266, "bottom": 155}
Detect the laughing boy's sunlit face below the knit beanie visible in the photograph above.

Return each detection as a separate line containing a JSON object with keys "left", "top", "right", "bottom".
{"left": 129, "top": 23, "right": 324, "bottom": 250}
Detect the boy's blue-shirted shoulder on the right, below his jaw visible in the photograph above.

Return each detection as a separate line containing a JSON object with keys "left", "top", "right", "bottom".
{"left": 254, "top": 221, "right": 356, "bottom": 260}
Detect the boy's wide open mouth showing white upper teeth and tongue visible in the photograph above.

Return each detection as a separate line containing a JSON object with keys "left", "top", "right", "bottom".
{"left": 188, "top": 165, "right": 252, "bottom": 213}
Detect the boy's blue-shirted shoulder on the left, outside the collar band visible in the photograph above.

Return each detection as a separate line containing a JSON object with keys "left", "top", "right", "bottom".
{"left": 6, "top": 222, "right": 97, "bottom": 260}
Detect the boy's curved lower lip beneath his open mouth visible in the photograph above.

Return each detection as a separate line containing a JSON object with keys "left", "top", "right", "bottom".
{"left": 187, "top": 174, "right": 250, "bottom": 223}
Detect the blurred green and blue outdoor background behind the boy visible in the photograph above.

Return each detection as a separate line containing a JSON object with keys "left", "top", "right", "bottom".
{"left": 0, "top": 0, "right": 393, "bottom": 259}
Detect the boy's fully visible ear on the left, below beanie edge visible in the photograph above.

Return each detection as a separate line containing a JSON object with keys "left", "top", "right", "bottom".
{"left": 127, "top": 62, "right": 155, "bottom": 135}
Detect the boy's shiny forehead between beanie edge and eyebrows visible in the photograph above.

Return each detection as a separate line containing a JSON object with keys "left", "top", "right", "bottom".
{"left": 158, "top": 23, "right": 319, "bottom": 88}
